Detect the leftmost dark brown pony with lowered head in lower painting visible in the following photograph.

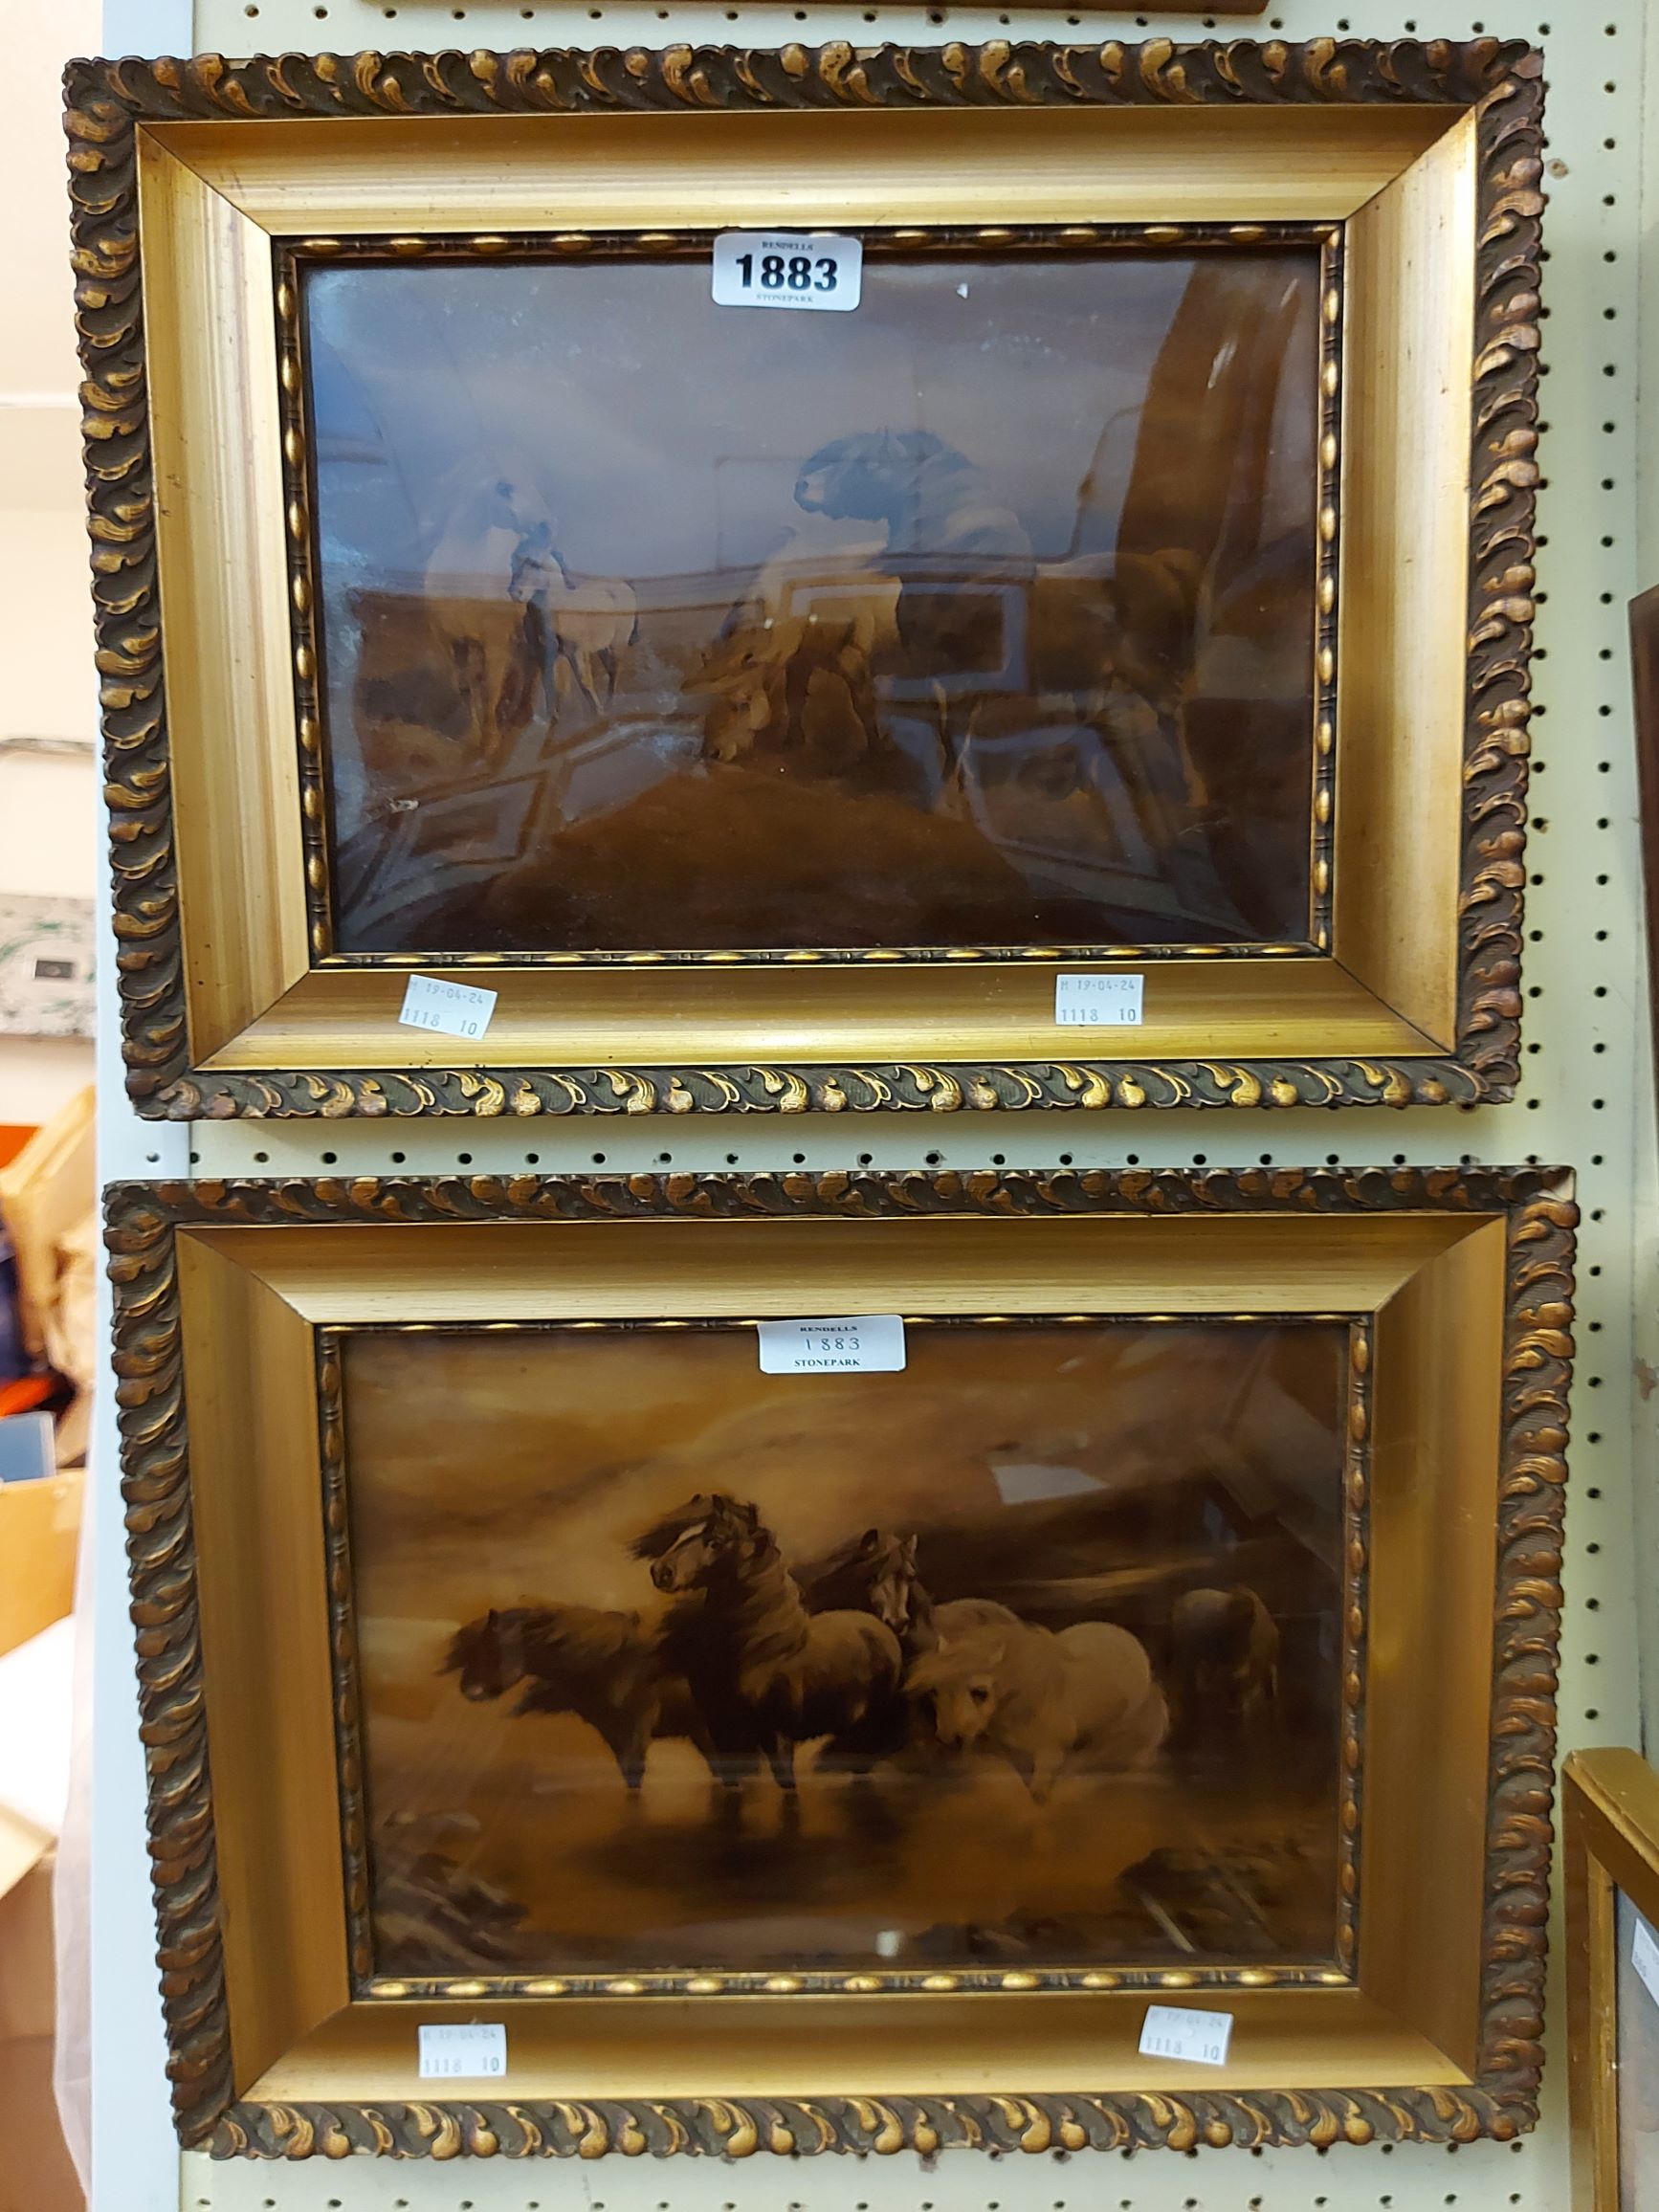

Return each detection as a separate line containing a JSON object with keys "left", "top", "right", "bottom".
{"left": 440, "top": 1606, "right": 710, "bottom": 1789}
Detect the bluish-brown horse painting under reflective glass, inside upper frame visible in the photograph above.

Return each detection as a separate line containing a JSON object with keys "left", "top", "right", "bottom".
{"left": 303, "top": 246, "right": 1318, "bottom": 953}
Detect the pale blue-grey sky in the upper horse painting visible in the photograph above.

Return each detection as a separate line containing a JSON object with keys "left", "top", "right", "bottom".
{"left": 305, "top": 254, "right": 1310, "bottom": 582}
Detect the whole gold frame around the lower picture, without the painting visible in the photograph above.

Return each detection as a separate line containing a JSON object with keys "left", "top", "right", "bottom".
{"left": 106, "top": 1168, "right": 1575, "bottom": 2157}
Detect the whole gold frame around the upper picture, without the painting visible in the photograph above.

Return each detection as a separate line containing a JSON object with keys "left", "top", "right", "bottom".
{"left": 69, "top": 37, "right": 1541, "bottom": 1117}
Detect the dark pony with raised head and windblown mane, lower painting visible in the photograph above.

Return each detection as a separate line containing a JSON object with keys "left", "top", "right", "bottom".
{"left": 632, "top": 1493, "right": 902, "bottom": 1789}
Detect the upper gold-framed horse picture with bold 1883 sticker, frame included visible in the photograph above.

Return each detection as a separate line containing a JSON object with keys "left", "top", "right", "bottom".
{"left": 69, "top": 37, "right": 1541, "bottom": 1115}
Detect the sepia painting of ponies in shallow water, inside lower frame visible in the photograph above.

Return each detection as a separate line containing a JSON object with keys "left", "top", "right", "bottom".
{"left": 345, "top": 1323, "right": 1347, "bottom": 1976}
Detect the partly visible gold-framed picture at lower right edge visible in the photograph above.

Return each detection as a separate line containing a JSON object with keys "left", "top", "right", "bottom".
{"left": 1561, "top": 1752, "right": 1659, "bottom": 2212}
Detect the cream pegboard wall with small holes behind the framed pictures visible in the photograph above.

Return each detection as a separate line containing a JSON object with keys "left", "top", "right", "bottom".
{"left": 93, "top": 0, "right": 1659, "bottom": 2212}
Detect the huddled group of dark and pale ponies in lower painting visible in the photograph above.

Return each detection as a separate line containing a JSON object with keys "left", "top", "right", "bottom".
{"left": 442, "top": 1493, "right": 1168, "bottom": 1803}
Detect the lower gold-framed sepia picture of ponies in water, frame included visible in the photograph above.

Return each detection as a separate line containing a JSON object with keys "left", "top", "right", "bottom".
{"left": 108, "top": 1168, "right": 1575, "bottom": 2157}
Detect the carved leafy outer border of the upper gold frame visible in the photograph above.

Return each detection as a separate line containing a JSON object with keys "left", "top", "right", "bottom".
{"left": 66, "top": 37, "right": 1541, "bottom": 1119}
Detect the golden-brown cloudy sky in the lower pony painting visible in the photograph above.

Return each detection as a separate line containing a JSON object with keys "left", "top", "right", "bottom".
{"left": 345, "top": 1323, "right": 1345, "bottom": 1622}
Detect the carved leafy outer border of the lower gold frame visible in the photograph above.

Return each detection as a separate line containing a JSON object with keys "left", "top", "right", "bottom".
{"left": 106, "top": 1168, "right": 1577, "bottom": 2157}
